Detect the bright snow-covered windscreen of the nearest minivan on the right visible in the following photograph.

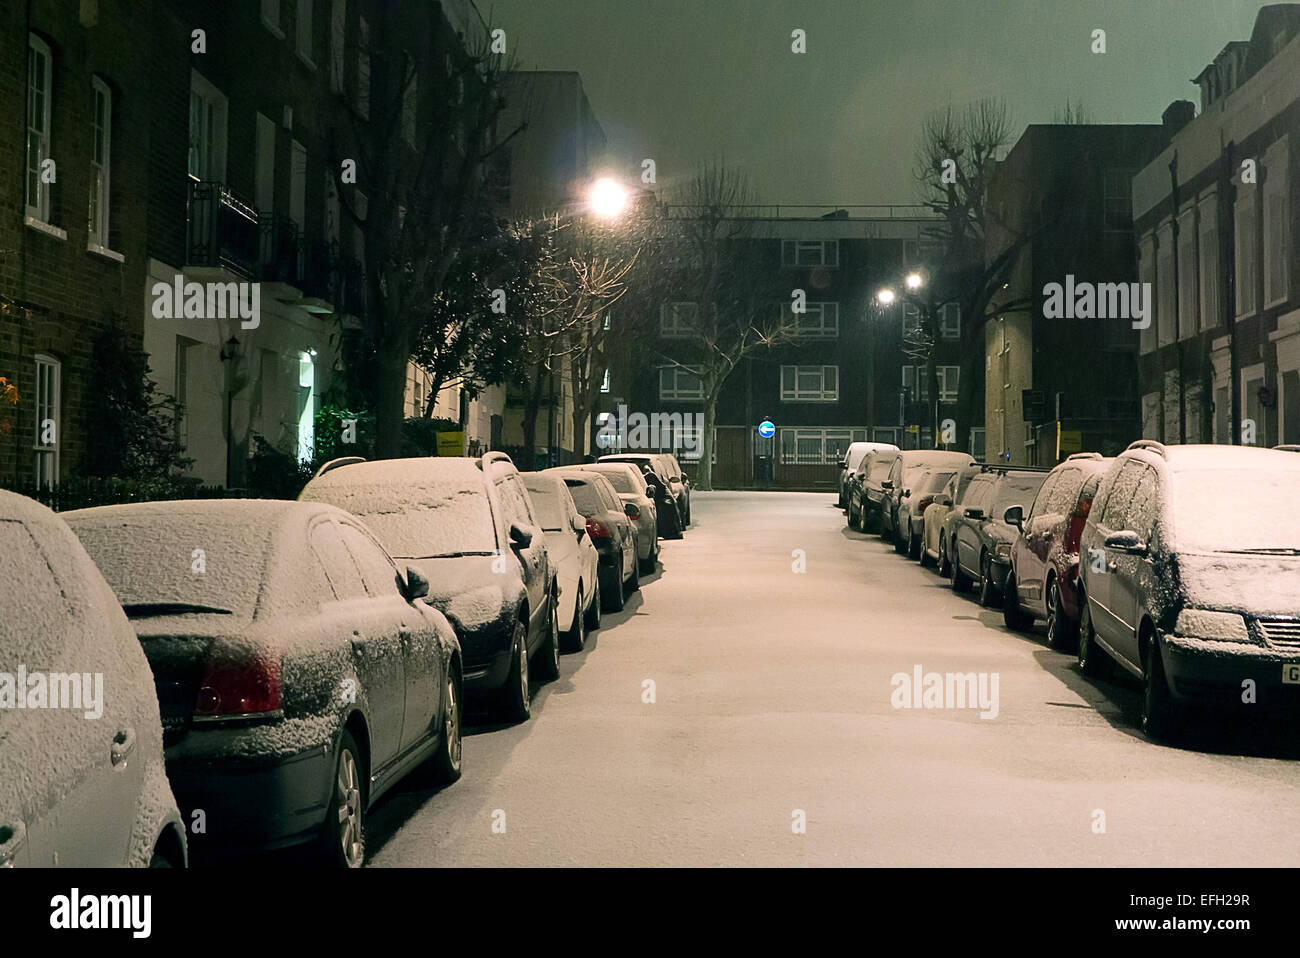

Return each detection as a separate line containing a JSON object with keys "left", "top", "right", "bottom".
{"left": 1169, "top": 468, "right": 1300, "bottom": 552}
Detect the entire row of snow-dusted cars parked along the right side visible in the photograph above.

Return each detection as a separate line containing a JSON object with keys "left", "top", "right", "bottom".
{"left": 844, "top": 439, "right": 1300, "bottom": 741}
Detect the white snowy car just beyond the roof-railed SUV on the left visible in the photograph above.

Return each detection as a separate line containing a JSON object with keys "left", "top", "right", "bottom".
{"left": 523, "top": 472, "right": 601, "bottom": 653}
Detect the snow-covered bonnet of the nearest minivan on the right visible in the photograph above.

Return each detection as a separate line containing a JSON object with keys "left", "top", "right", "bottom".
{"left": 1174, "top": 552, "right": 1300, "bottom": 617}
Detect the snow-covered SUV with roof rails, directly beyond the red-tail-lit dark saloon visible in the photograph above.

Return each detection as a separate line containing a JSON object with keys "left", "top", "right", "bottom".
{"left": 299, "top": 452, "right": 560, "bottom": 721}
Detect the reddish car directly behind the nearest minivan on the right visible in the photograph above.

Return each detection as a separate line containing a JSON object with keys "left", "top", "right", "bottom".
{"left": 1002, "top": 452, "right": 1112, "bottom": 650}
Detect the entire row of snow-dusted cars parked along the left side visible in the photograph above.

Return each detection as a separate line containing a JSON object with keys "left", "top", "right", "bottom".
{"left": 0, "top": 452, "right": 689, "bottom": 867}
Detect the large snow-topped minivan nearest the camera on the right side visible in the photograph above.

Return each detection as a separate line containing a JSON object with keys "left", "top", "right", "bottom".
{"left": 1078, "top": 439, "right": 1300, "bottom": 740}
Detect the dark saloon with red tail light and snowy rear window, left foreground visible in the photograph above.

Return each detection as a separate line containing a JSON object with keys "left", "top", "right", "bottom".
{"left": 65, "top": 499, "right": 462, "bottom": 867}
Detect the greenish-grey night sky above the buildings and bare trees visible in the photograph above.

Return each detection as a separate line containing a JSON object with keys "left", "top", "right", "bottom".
{"left": 477, "top": 0, "right": 1268, "bottom": 205}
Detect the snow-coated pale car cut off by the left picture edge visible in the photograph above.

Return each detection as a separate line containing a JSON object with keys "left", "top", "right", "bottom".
{"left": 0, "top": 491, "right": 187, "bottom": 868}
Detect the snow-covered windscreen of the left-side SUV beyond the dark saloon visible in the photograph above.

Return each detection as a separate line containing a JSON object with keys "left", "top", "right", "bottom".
{"left": 321, "top": 477, "right": 497, "bottom": 559}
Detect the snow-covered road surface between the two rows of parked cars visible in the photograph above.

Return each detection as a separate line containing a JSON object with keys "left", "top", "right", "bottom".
{"left": 369, "top": 493, "right": 1300, "bottom": 866}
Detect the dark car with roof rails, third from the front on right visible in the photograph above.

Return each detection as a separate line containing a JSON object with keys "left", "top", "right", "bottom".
{"left": 948, "top": 467, "right": 1048, "bottom": 606}
